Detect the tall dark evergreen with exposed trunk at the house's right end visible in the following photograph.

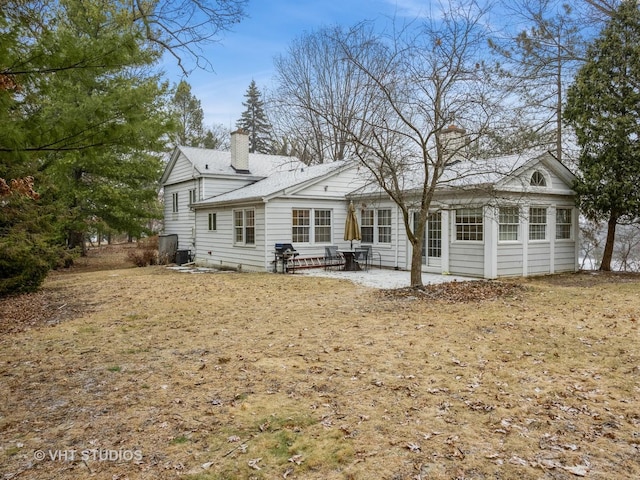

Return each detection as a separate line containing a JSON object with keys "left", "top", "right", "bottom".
{"left": 564, "top": 0, "right": 640, "bottom": 270}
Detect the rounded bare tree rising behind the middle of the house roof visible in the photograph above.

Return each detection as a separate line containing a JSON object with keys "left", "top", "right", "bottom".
{"left": 270, "top": 25, "right": 372, "bottom": 163}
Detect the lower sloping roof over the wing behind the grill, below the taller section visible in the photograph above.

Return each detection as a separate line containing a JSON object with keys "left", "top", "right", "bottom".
{"left": 193, "top": 160, "right": 355, "bottom": 208}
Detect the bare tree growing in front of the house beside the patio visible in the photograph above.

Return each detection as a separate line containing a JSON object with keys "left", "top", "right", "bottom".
{"left": 298, "top": 3, "right": 508, "bottom": 287}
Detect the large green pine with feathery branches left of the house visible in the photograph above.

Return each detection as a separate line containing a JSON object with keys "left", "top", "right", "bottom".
{"left": 0, "top": 0, "right": 173, "bottom": 293}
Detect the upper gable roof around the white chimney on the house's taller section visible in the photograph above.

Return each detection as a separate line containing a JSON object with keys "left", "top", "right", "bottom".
{"left": 160, "top": 146, "right": 304, "bottom": 184}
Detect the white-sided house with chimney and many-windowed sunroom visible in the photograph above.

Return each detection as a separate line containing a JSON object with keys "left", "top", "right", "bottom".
{"left": 161, "top": 128, "right": 579, "bottom": 278}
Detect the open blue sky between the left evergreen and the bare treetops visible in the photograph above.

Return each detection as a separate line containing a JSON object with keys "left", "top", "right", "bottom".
{"left": 164, "top": 0, "right": 431, "bottom": 129}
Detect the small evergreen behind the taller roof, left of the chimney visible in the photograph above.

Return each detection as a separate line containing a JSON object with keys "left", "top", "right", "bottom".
{"left": 171, "top": 80, "right": 205, "bottom": 147}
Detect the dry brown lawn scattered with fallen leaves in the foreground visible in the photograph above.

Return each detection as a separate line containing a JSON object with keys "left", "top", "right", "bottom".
{"left": 0, "top": 246, "right": 640, "bottom": 480}
